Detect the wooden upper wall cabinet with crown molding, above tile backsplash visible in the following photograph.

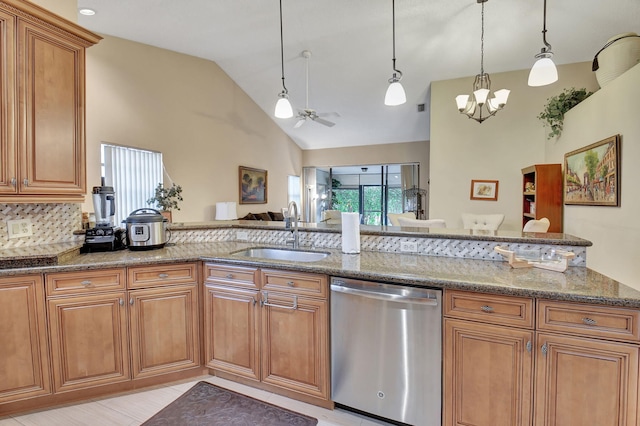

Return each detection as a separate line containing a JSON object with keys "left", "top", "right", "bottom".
{"left": 0, "top": 0, "right": 101, "bottom": 202}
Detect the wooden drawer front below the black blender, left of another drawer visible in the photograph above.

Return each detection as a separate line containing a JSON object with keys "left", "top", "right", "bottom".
{"left": 46, "top": 269, "right": 126, "bottom": 297}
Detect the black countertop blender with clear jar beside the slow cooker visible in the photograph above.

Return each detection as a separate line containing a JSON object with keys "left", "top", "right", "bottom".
{"left": 80, "top": 178, "right": 126, "bottom": 253}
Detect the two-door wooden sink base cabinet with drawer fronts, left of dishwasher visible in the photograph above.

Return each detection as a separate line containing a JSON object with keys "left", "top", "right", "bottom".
{"left": 204, "top": 264, "right": 330, "bottom": 406}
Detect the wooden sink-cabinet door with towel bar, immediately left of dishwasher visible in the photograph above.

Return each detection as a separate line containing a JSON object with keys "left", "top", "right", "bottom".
{"left": 262, "top": 291, "right": 329, "bottom": 399}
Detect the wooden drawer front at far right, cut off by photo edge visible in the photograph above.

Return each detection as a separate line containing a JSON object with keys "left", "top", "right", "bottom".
{"left": 538, "top": 300, "right": 640, "bottom": 342}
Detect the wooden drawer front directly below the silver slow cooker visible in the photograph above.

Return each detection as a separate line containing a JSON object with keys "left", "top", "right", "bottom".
{"left": 129, "top": 263, "right": 198, "bottom": 288}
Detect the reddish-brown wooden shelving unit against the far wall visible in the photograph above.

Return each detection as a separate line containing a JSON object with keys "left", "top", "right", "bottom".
{"left": 522, "top": 164, "right": 563, "bottom": 232}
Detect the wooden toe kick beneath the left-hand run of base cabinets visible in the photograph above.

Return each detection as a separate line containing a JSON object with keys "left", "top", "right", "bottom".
{"left": 0, "top": 366, "right": 209, "bottom": 417}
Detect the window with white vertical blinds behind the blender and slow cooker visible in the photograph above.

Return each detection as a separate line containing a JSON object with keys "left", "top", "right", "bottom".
{"left": 101, "top": 143, "right": 163, "bottom": 225}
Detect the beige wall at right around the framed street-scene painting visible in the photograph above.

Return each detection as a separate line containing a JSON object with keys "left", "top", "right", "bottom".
{"left": 546, "top": 65, "right": 640, "bottom": 290}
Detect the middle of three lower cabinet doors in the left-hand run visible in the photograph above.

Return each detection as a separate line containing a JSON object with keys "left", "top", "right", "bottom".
{"left": 48, "top": 292, "right": 131, "bottom": 392}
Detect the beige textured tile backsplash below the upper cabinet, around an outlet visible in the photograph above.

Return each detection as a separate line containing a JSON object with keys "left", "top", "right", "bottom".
{"left": 0, "top": 203, "right": 83, "bottom": 249}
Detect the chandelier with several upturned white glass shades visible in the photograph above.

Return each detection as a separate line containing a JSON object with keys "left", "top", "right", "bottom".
{"left": 456, "top": 0, "right": 510, "bottom": 123}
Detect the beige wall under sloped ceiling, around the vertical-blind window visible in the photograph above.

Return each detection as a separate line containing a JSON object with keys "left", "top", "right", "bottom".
{"left": 83, "top": 36, "right": 302, "bottom": 222}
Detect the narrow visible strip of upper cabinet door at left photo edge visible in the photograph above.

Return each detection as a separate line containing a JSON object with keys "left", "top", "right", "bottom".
{"left": 0, "top": 10, "right": 17, "bottom": 194}
